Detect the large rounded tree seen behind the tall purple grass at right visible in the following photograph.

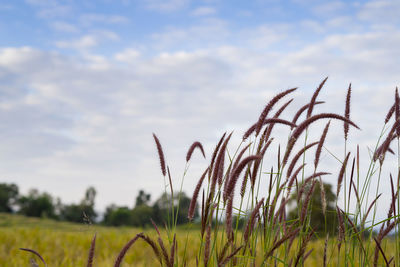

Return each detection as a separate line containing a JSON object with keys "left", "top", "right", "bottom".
{"left": 288, "top": 180, "right": 338, "bottom": 237}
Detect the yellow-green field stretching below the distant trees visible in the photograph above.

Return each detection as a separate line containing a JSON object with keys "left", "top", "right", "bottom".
{"left": 0, "top": 213, "right": 394, "bottom": 267}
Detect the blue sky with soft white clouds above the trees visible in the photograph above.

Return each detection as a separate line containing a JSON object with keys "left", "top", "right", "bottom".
{"left": 0, "top": 0, "right": 400, "bottom": 220}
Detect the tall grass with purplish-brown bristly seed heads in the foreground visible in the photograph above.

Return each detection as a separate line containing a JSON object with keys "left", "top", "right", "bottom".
{"left": 19, "top": 78, "right": 400, "bottom": 267}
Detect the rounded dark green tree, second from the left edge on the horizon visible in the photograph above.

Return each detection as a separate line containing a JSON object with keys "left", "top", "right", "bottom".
{"left": 18, "top": 189, "right": 57, "bottom": 218}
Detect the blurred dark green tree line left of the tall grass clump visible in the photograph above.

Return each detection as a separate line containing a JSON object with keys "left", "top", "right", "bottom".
{"left": 0, "top": 183, "right": 198, "bottom": 227}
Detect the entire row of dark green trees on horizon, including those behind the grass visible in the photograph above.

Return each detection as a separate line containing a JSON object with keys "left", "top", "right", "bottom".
{"left": 0, "top": 182, "right": 344, "bottom": 234}
